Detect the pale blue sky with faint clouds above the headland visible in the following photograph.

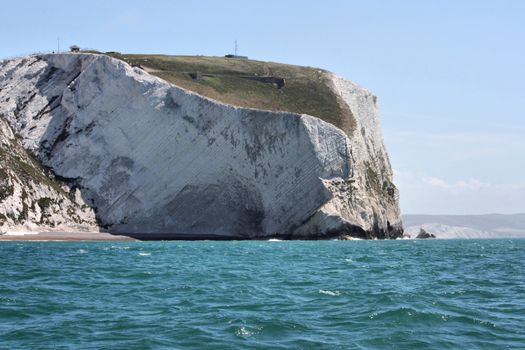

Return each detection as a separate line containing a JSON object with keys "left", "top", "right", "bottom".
{"left": 0, "top": 0, "right": 525, "bottom": 214}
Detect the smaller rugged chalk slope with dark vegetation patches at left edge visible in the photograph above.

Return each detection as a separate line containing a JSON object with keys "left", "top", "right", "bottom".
{"left": 0, "top": 119, "right": 97, "bottom": 232}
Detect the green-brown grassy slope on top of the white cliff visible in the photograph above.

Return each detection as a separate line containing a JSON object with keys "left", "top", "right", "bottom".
{"left": 106, "top": 52, "right": 353, "bottom": 132}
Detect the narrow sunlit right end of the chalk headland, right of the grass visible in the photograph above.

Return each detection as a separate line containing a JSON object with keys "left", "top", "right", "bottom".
{"left": 327, "top": 74, "right": 402, "bottom": 238}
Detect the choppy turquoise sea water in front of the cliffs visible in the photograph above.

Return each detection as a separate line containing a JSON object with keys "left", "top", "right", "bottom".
{"left": 0, "top": 240, "right": 525, "bottom": 349}
